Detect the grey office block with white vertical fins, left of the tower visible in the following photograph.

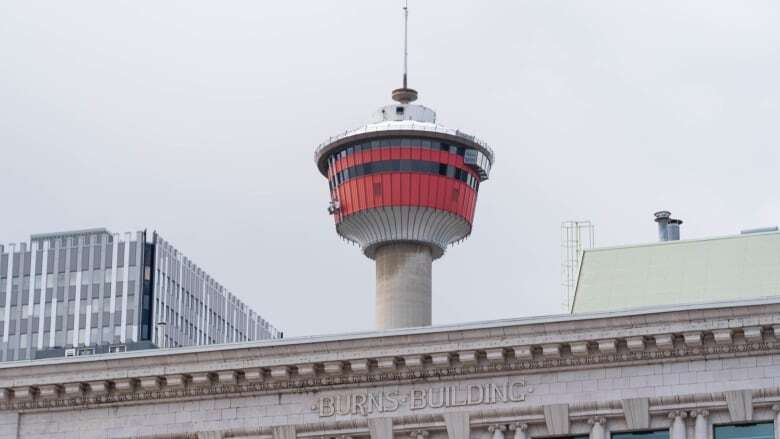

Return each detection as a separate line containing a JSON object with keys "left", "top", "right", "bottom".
{"left": 0, "top": 229, "right": 279, "bottom": 361}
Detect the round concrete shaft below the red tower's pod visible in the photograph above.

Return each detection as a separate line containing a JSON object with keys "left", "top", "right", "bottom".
{"left": 374, "top": 242, "right": 433, "bottom": 330}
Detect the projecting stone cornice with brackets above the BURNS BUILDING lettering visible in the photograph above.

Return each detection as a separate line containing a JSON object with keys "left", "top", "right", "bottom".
{"left": 0, "top": 304, "right": 780, "bottom": 410}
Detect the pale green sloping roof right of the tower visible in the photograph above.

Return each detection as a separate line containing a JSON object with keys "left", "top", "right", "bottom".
{"left": 572, "top": 232, "right": 780, "bottom": 313}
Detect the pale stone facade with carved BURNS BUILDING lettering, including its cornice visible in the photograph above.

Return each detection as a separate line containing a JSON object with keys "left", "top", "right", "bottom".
{"left": 0, "top": 300, "right": 780, "bottom": 439}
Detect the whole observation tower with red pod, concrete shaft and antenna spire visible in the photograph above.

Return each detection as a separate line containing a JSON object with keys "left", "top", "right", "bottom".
{"left": 315, "top": 0, "right": 494, "bottom": 330}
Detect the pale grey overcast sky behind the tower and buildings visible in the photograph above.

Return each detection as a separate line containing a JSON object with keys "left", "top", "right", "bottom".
{"left": 0, "top": 0, "right": 780, "bottom": 335}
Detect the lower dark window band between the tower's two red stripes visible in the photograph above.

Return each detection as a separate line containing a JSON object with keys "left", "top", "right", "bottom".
{"left": 330, "top": 160, "right": 479, "bottom": 191}
